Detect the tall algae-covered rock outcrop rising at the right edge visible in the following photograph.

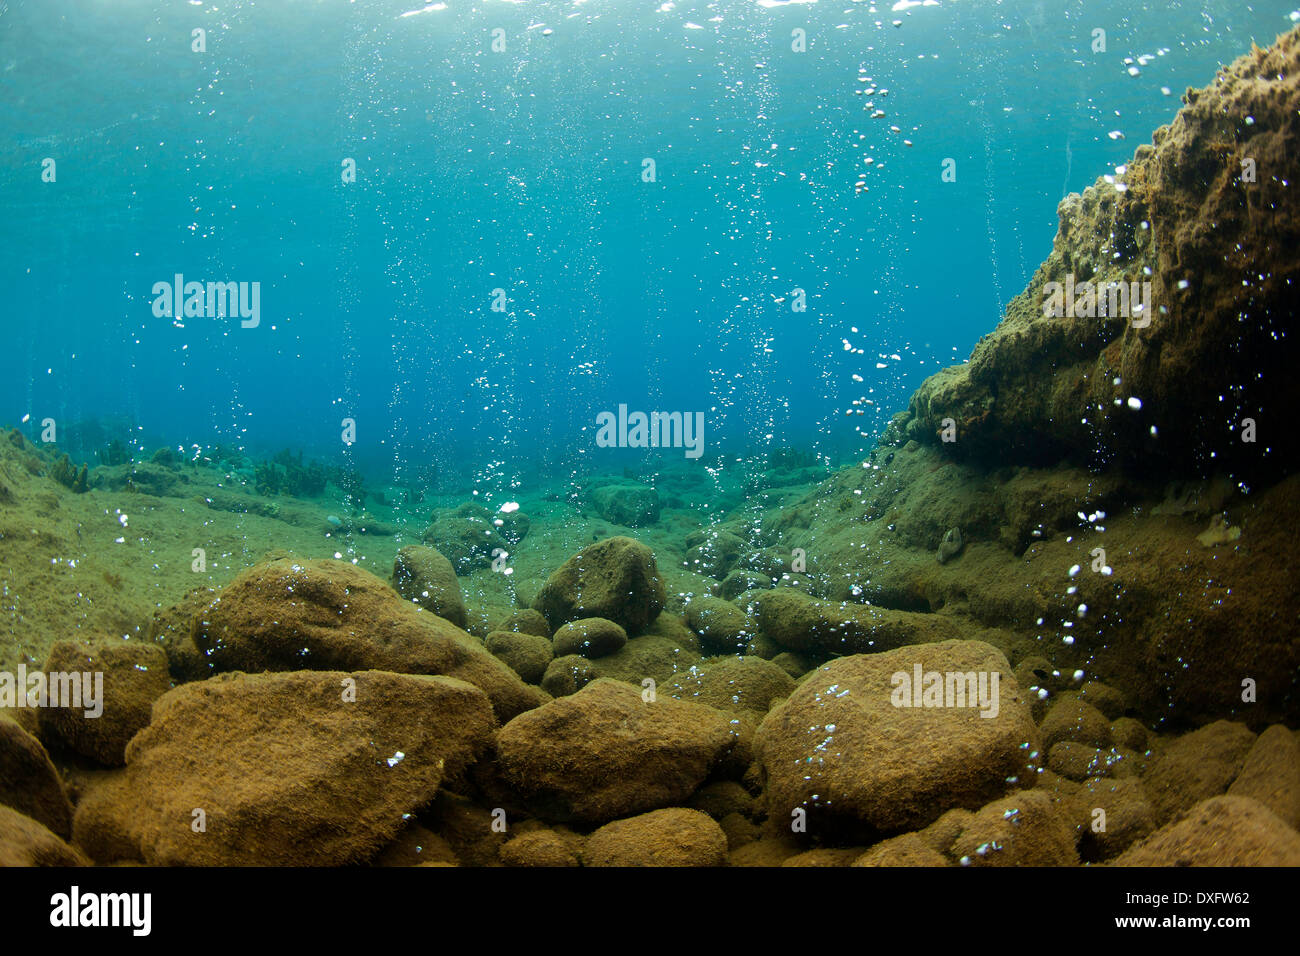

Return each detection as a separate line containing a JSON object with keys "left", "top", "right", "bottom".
{"left": 901, "top": 30, "right": 1300, "bottom": 486}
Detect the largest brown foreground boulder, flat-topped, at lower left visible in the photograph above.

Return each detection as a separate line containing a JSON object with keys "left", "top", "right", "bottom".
{"left": 73, "top": 671, "right": 497, "bottom": 866}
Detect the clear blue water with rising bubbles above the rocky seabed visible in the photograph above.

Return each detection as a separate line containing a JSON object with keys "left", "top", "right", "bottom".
{"left": 0, "top": 0, "right": 1294, "bottom": 481}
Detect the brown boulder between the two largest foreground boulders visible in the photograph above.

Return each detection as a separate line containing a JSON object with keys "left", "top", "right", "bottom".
{"left": 497, "top": 679, "right": 733, "bottom": 823}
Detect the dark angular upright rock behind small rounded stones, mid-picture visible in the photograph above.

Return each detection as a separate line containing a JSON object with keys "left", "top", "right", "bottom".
{"left": 533, "top": 537, "right": 667, "bottom": 636}
